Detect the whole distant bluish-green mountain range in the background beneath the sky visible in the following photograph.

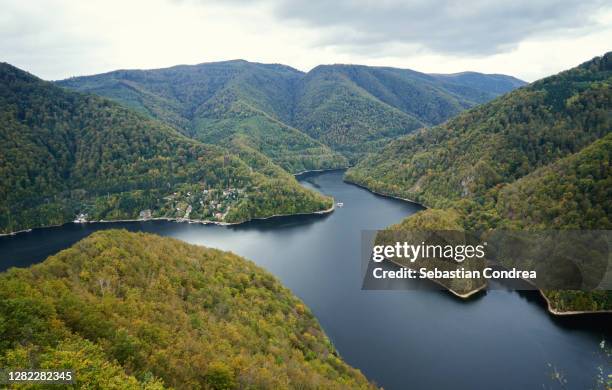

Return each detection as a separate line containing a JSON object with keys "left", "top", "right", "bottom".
{"left": 59, "top": 61, "right": 522, "bottom": 165}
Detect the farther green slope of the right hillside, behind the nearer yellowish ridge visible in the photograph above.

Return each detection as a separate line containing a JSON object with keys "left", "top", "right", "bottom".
{"left": 347, "top": 54, "right": 612, "bottom": 207}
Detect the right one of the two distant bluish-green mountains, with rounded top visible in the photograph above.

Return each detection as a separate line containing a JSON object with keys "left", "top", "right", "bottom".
{"left": 294, "top": 65, "right": 524, "bottom": 156}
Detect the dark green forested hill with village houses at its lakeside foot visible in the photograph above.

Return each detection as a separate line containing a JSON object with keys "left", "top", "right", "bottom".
{"left": 0, "top": 64, "right": 331, "bottom": 232}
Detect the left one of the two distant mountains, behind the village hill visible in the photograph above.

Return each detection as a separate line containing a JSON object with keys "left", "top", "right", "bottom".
{"left": 59, "top": 61, "right": 347, "bottom": 173}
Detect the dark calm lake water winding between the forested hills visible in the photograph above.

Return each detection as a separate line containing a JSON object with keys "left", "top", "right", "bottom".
{"left": 0, "top": 171, "right": 612, "bottom": 389}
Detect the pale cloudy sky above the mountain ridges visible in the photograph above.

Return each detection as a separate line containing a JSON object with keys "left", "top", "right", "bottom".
{"left": 0, "top": 0, "right": 612, "bottom": 81}
